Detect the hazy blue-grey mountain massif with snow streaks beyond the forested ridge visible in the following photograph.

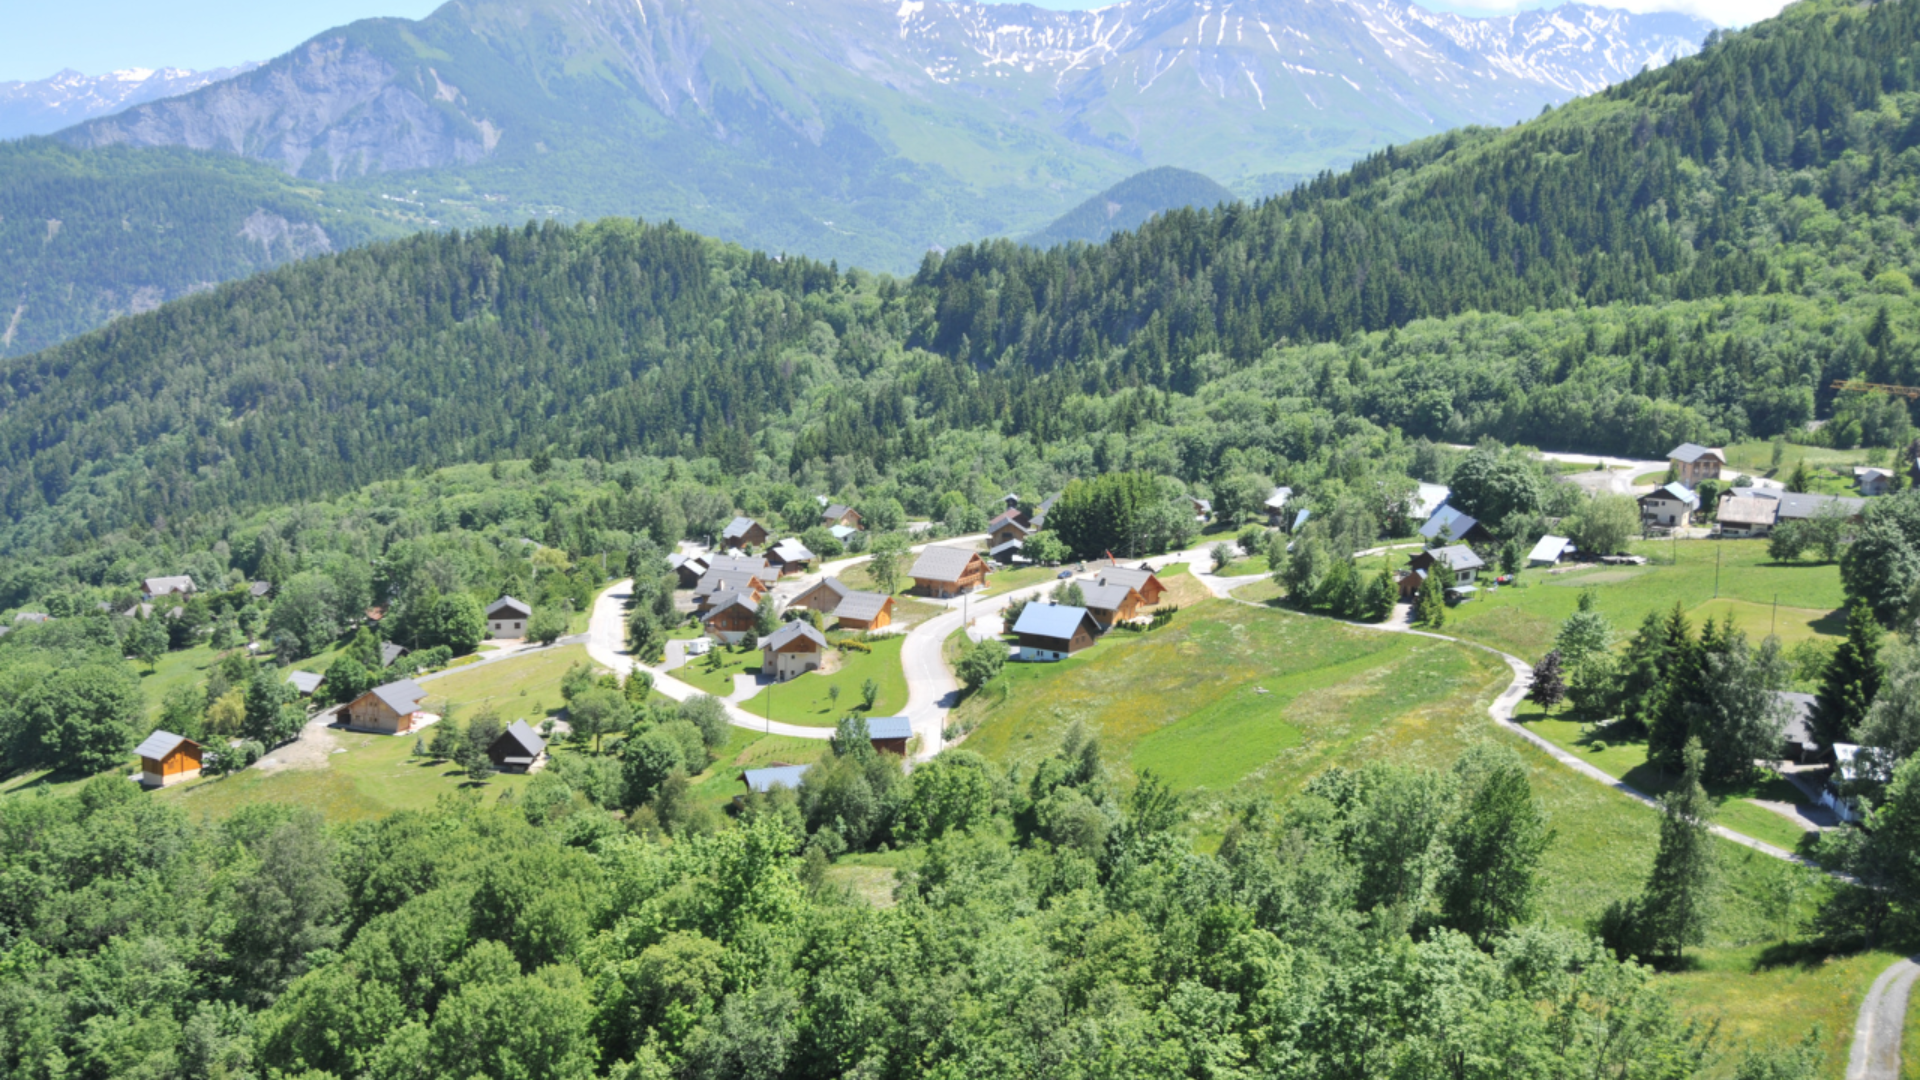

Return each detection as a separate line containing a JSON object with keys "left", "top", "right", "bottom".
{"left": 60, "top": 0, "right": 1711, "bottom": 261}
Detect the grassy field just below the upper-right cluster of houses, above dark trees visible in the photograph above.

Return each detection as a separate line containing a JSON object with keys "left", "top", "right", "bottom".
{"left": 1443, "top": 540, "right": 1845, "bottom": 661}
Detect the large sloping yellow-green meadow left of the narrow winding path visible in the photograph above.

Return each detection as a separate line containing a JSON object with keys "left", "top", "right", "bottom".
{"left": 954, "top": 601, "right": 1811, "bottom": 947}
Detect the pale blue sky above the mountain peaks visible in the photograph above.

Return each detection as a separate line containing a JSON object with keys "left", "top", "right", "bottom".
{"left": 0, "top": 0, "right": 1780, "bottom": 81}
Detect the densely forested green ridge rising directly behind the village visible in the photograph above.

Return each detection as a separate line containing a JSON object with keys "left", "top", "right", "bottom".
{"left": 0, "top": 0, "right": 1920, "bottom": 552}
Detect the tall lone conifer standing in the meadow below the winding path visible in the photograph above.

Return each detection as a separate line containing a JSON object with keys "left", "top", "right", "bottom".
{"left": 1640, "top": 740, "right": 1713, "bottom": 961}
